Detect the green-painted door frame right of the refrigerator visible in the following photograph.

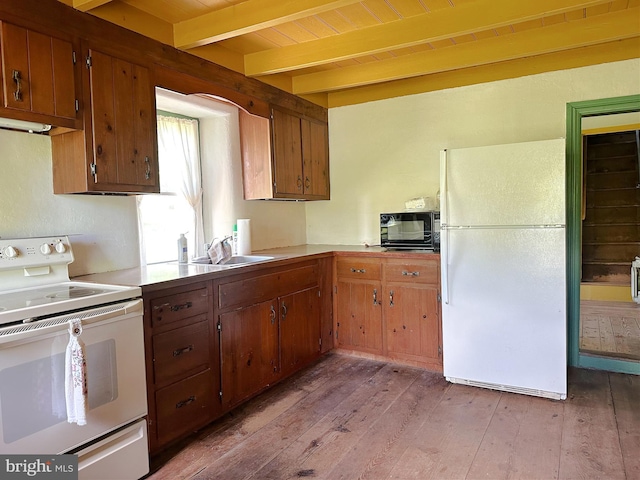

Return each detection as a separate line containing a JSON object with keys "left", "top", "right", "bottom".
{"left": 566, "top": 95, "right": 640, "bottom": 375}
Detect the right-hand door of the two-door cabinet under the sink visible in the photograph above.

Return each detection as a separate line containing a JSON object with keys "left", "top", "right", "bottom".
{"left": 278, "top": 288, "right": 320, "bottom": 375}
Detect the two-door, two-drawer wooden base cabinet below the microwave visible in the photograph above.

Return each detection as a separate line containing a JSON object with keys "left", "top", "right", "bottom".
{"left": 335, "top": 253, "right": 442, "bottom": 371}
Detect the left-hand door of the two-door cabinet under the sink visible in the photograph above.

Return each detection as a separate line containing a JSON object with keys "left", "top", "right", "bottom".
{"left": 219, "top": 301, "right": 279, "bottom": 410}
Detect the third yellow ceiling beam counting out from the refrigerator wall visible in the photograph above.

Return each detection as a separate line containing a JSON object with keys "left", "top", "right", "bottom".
{"left": 245, "top": 0, "right": 608, "bottom": 76}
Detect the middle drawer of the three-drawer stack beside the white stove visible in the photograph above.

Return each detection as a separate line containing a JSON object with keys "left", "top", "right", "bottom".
{"left": 153, "top": 315, "right": 210, "bottom": 385}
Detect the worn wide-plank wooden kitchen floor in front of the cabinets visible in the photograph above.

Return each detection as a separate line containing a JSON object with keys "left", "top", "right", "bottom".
{"left": 148, "top": 353, "right": 640, "bottom": 480}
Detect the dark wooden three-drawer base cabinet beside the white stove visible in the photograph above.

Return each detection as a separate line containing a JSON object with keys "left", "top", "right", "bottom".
{"left": 142, "top": 282, "right": 222, "bottom": 454}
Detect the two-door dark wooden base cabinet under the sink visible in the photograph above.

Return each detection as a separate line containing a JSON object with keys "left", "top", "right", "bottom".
{"left": 214, "top": 261, "right": 328, "bottom": 410}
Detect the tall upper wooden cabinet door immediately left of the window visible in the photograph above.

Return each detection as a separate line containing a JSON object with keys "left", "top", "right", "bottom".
{"left": 90, "top": 50, "right": 159, "bottom": 191}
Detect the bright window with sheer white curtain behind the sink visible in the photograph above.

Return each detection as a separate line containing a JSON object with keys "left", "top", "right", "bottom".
{"left": 138, "top": 112, "right": 203, "bottom": 264}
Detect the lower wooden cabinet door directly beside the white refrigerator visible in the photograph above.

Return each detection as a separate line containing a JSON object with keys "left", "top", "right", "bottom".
{"left": 383, "top": 284, "right": 440, "bottom": 363}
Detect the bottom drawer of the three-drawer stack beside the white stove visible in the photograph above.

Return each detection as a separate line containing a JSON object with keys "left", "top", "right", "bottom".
{"left": 156, "top": 369, "right": 218, "bottom": 443}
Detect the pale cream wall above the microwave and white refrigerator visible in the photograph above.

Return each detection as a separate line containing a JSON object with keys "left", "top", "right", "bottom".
{"left": 306, "top": 59, "right": 640, "bottom": 244}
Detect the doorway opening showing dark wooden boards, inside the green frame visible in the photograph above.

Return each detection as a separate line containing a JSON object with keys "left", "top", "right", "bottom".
{"left": 580, "top": 127, "right": 640, "bottom": 361}
